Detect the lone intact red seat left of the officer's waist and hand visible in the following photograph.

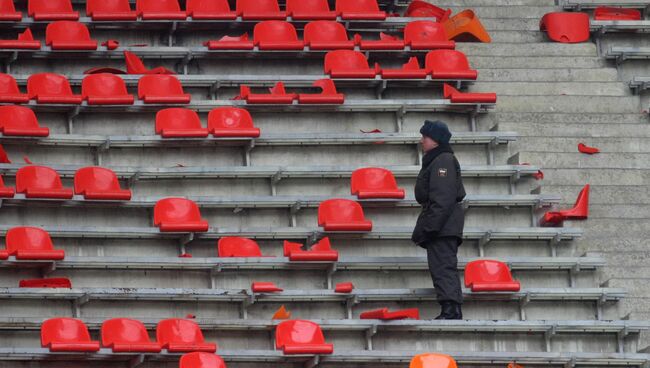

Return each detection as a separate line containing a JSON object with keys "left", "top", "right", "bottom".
{"left": 318, "top": 199, "right": 372, "bottom": 231}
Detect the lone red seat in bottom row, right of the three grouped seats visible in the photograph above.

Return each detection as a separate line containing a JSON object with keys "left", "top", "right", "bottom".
{"left": 275, "top": 320, "right": 334, "bottom": 354}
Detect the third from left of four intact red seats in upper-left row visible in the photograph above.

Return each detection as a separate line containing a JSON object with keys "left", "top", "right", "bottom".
{"left": 81, "top": 73, "right": 135, "bottom": 105}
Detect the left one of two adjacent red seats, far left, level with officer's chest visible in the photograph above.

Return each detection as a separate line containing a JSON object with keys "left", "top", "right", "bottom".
{"left": 16, "top": 165, "right": 72, "bottom": 199}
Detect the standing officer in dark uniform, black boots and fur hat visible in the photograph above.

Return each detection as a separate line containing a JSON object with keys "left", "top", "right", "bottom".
{"left": 411, "top": 120, "right": 465, "bottom": 319}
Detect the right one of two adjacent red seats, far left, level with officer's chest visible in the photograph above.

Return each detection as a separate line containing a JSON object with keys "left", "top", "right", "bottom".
{"left": 74, "top": 166, "right": 131, "bottom": 201}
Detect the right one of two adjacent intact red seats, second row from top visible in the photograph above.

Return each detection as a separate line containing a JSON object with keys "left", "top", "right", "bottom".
{"left": 304, "top": 20, "right": 354, "bottom": 50}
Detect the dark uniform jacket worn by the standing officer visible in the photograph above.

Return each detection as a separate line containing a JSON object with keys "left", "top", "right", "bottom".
{"left": 411, "top": 144, "right": 465, "bottom": 247}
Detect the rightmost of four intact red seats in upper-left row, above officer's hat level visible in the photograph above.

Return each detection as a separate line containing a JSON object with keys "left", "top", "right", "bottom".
{"left": 138, "top": 75, "right": 192, "bottom": 104}
